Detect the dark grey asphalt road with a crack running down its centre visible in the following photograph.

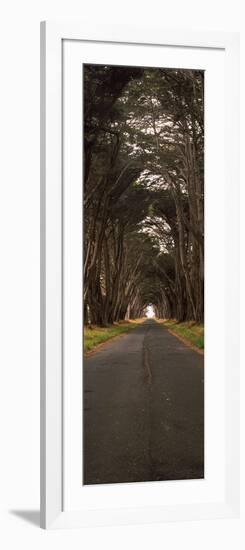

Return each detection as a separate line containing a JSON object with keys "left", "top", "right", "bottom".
{"left": 83, "top": 320, "right": 204, "bottom": 484}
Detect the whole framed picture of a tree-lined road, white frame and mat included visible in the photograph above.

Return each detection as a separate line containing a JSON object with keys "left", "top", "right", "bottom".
{"left": 41, "top": 23, "right": 239, "bottom": 528}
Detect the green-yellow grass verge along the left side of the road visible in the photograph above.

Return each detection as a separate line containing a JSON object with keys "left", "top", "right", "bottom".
{"left": 83, "top": 319, "right": 144, "bottom": 353}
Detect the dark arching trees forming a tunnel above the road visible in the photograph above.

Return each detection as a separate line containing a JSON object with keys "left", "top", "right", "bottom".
{"left": 84, "top": 65, "right": 204, "bottom": 325}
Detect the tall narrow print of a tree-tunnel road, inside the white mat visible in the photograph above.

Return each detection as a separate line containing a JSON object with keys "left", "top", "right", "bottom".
{"left": 82, "top": 64, "right": 204, "bottom": 485}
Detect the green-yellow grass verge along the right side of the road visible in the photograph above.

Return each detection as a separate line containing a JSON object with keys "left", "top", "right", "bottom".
{"left": 159, "top": 319, "right": 204, "bottom": 350}
